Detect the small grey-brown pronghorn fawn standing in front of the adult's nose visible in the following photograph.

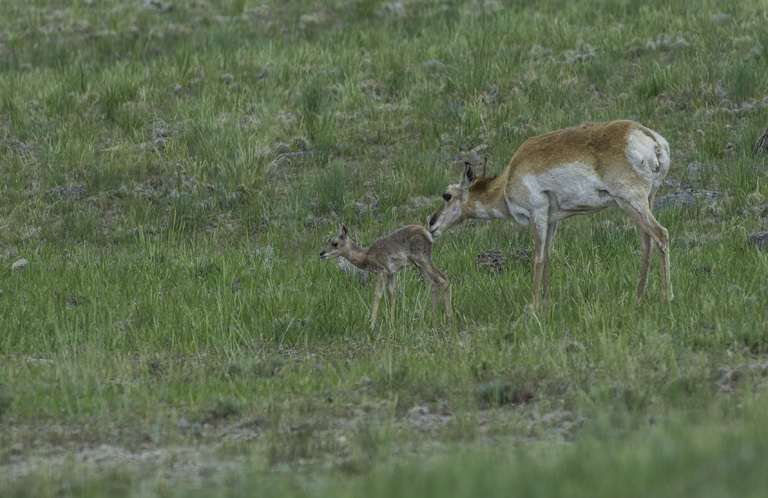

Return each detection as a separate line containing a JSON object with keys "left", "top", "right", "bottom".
{"left": 320, "top": 223, "right": 451, "bottom": 330}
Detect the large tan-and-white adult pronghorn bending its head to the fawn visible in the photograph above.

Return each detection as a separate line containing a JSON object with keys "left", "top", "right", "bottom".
{"left": 428, "top": 121, "right": 672, "bottom": 305}
